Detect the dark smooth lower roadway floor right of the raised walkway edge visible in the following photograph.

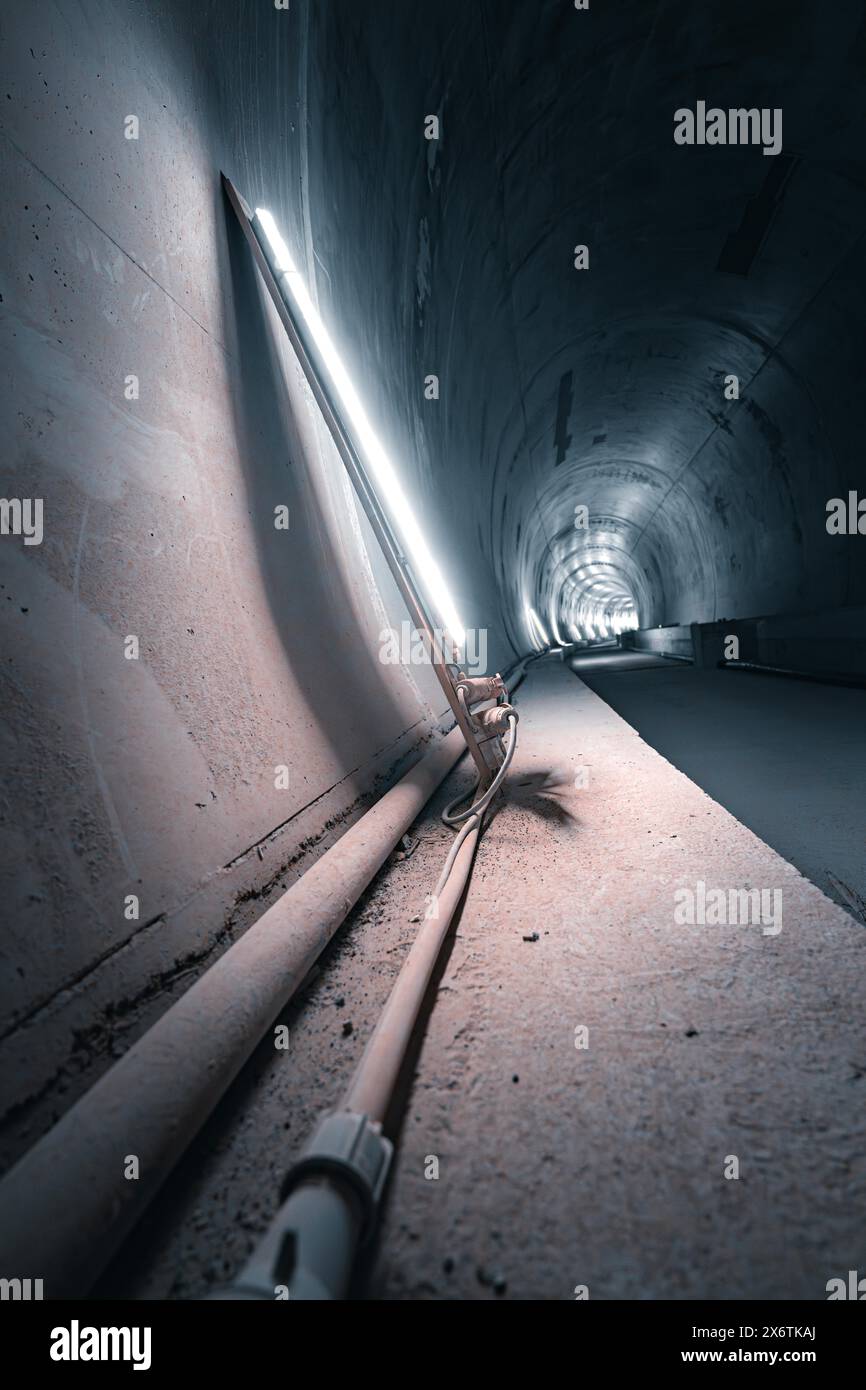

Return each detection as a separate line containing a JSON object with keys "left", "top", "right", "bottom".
{"left": 571, "top": 651, "right": 866, "bottom": 924}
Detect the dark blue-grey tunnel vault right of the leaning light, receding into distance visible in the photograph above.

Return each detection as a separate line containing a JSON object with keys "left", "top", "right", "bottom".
{"left": 283, "top": 0, "right": 866, "bottom": 651}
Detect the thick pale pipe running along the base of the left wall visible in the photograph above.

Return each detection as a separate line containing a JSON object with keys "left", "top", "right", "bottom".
{"left": 0, "top": 728, "right": 466, "bottom": 1298}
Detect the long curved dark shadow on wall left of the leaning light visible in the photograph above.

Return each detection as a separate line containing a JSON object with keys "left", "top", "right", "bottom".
{"left": 221, "top": 196, "right": 427, "bottom": 771}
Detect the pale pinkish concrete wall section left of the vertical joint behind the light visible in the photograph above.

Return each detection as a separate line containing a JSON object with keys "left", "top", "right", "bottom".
{"left": 0, "top": 0, "right": 507, "bottom": 1166}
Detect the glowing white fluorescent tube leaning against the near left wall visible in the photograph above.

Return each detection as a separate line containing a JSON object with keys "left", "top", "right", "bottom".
{"left": 256, "top": 207, "right": 466, "bottom": 646}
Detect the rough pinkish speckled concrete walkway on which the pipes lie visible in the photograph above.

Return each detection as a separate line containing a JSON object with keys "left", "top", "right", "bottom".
{"left": 101, "top": 664, "right": 866, "bottom": 1300}
